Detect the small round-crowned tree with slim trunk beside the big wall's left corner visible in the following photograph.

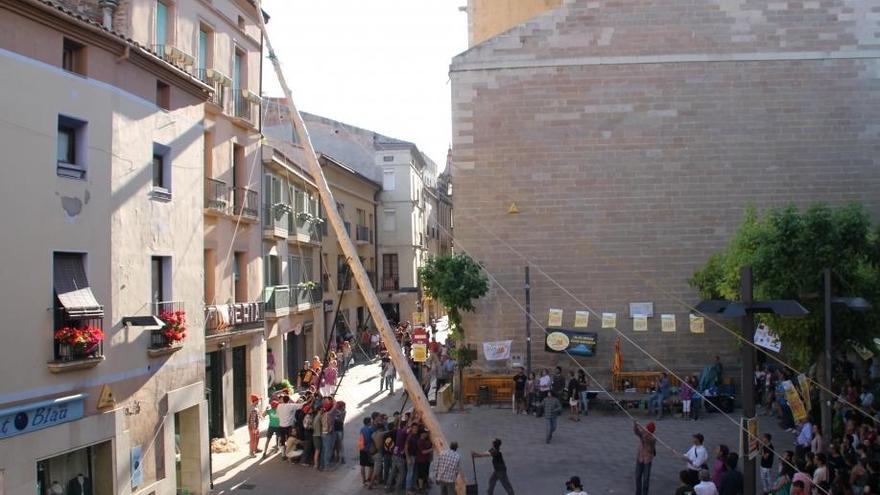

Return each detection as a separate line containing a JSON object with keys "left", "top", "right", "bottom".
{"left": 419, "top": 254, "right": 489, "bottom": 405}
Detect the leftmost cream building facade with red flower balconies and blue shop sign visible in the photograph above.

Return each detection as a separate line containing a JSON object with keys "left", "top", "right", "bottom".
{"left": 0, "top": 0, "right": 212, "bottom": 494}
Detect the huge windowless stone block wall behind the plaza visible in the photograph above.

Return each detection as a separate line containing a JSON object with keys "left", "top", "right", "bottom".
{"left": 451, "top": 0, "right": 880, "bottom": 383}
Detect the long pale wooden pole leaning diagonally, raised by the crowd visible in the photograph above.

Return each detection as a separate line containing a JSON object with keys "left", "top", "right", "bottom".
{"left": 257, "top": 5, "right": 465, "bottom": 495}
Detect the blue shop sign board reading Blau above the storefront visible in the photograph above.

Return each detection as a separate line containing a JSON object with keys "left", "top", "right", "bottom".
{"left": 0, "top": 394, "right": 86, "bottom": 438}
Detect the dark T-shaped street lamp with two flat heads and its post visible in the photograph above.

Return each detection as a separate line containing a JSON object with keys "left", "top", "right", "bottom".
{"left": 695, "top": 266, "right": 808, "bottom": 495}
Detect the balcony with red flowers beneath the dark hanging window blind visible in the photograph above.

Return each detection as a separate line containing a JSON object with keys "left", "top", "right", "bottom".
{"left": 48, "top": 308, "right": 104, "bottom": 373}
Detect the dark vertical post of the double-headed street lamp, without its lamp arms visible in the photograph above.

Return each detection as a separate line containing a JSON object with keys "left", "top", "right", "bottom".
{"left": 740, "top": 266, "right": 758, "bottom": 495}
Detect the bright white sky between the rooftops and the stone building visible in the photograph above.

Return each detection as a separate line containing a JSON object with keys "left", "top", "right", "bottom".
{"left": 263, "top": 0, "right": 467, "bottom": 168}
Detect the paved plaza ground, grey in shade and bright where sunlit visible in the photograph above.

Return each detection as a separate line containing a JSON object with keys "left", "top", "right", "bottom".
{"left": 212, "top": 363, "right": 794, "bottom": 495}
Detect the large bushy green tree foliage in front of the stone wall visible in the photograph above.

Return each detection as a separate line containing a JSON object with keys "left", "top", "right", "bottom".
{"left": 690, "top": 204, "right": 880, "bottom": 366}
